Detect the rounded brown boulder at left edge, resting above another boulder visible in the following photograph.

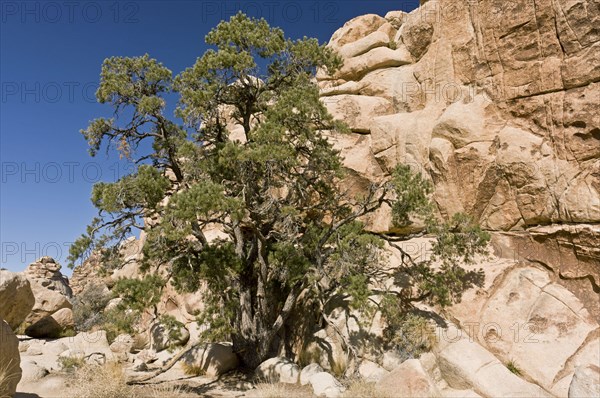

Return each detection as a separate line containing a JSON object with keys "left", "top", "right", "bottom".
{"left": 0, "top": 270, "right": 35, "bottom": 329}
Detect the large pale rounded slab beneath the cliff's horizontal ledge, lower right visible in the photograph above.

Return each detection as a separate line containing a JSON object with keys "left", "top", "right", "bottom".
{"left": 478, "top": 267, "right": 600, "bottom": 395}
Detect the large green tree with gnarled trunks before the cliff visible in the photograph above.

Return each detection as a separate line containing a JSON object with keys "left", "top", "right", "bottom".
{"left": 70, "top": 13, "right": 488, "bottom": 366}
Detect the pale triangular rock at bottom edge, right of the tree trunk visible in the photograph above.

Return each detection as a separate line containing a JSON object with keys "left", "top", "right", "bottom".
{"left": 375, "top": 359, "right": 440, "bottom": 398}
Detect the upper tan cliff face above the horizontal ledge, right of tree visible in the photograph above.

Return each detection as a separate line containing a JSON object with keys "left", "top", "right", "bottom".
{"left": 318, "top": 0, "right": 600, "bottom": 236}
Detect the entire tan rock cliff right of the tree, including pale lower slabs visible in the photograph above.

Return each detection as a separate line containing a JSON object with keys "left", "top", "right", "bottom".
{"left": 317, "top": 0, "right": 600, "bottom": 396}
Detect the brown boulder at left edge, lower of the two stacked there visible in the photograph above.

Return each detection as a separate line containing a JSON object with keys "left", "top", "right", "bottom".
{"left": 0, "top": 318, "right": 22, "bottom": 397}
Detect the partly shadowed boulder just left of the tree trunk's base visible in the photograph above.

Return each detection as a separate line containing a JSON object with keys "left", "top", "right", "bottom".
{"left": 184, "top": 343, "right": 239, "bottom": 377}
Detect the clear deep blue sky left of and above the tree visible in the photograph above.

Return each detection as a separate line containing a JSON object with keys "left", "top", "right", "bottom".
{"left": 0, "top": 0, "right": 418, "bottom": 274}
